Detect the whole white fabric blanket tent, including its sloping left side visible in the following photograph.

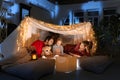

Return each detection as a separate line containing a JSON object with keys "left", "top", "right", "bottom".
{"left": 2, "top": 17, "right": 97, "bottom": 57}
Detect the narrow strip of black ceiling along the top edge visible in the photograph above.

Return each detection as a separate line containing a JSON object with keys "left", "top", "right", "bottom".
{"left": 48, "top": 0, "right": 109, "bottom": 5}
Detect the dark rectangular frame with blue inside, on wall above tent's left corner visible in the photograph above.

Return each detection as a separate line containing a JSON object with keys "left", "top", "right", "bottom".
{"left": 20, "top": 3, "right": 31, "bottom": 21}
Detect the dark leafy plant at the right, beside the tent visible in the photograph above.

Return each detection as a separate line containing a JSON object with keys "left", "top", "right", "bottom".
{"left": 94, "top": 14, "right": 120, "bottom": 55}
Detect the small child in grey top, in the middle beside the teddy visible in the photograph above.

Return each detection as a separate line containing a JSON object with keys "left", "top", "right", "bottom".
{"left": 53, "top": 38, "right": 64, "bottom": 55}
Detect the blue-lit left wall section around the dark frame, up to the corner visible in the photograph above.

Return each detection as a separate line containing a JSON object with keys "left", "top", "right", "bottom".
{"left": 2, "top": 0, "right": 54, "bottom": 25}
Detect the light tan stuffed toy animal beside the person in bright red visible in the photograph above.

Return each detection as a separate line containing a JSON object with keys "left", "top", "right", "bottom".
{"left": 41, "top": 46, "right": 52, "bottom": 58}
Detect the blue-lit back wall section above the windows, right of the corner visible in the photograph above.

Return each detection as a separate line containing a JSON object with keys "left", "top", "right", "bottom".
{"left": 55, "top": 0, "right": 120, "bottom": 24}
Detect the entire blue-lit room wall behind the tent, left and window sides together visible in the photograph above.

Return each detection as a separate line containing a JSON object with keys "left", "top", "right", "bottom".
{"left": 2, "top": 0, "right": 120, "bottom": 25}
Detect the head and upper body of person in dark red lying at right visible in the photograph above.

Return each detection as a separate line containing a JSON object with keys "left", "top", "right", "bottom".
{"left": 70, "top": 41, "right": 92, "bottom": 57}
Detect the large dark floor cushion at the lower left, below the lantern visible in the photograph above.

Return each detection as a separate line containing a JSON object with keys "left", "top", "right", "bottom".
{"left": 4, "top": 59, "right": 55, "bottom": 80}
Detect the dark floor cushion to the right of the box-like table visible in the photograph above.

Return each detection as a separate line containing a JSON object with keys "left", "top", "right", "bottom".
{"left": 80, "top": 56, "right": 112, "bottom": 73}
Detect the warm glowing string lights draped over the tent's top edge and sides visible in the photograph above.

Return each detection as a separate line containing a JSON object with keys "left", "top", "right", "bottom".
{"left": 17, "top": 17, "right": 97, "bottom": 53}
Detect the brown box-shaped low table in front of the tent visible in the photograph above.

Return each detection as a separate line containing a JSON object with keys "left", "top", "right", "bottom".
{"left": 55, "top": 55, "right": 77, "bottom": 73}
